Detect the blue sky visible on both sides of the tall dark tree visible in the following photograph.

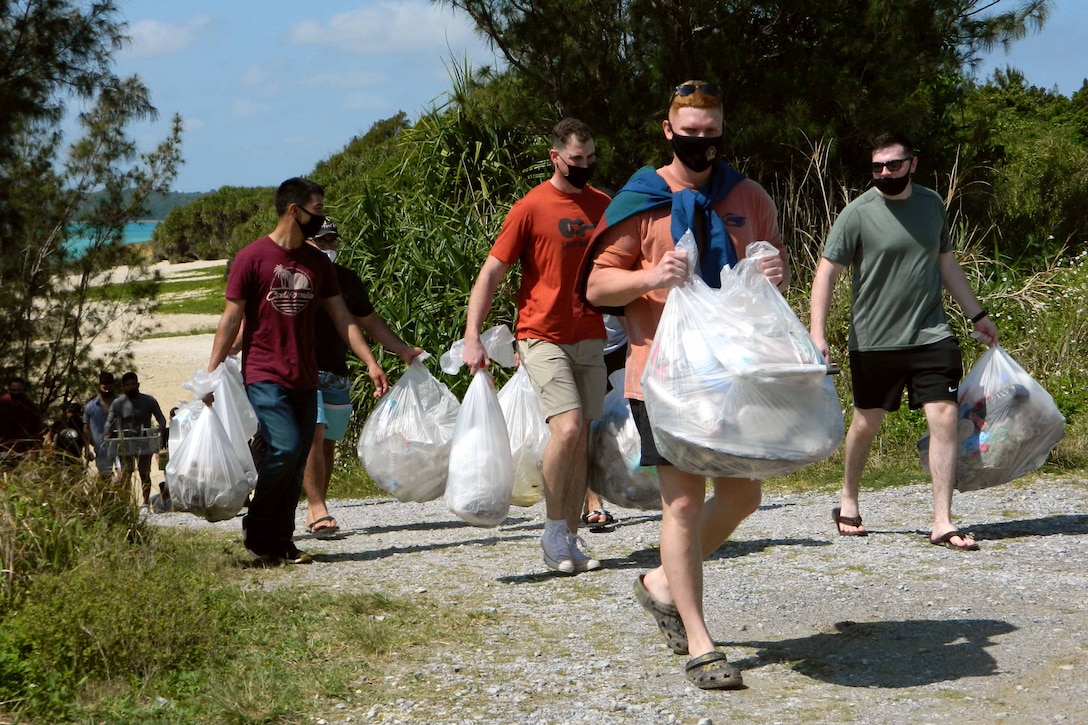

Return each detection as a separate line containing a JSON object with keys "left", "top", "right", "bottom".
{"left": 80, "top": 0, "right": 1088, "bottom": 192}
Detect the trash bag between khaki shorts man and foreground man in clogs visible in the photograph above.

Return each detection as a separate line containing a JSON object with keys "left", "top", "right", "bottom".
{"left": 589, "top": 368, "right": 662, "bottom": 511}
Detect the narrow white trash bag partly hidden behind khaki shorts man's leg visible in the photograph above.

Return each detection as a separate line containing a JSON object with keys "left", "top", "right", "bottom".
{"left": 498, "top": 366, "right": 552, "bottom": 506}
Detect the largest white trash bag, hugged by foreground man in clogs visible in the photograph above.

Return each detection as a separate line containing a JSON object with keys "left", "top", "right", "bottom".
{"left": 642, "top": 232, "right": 843, "bottom": 479}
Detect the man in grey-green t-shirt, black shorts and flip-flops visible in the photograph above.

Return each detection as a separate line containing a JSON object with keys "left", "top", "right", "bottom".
{"left": 809, "top": 134, "right": 998, "bottom": 551}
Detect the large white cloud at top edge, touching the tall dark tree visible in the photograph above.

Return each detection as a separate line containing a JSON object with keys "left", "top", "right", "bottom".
{"left": 286, "top": 0, "right": 481, "bottom": 56}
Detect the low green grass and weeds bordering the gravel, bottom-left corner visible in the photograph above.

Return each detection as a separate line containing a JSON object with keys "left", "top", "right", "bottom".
{"left": 0, "top": 522, "right": 484, "bottom": 723}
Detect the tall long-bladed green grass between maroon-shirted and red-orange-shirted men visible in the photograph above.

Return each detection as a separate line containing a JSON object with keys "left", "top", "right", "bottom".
{"left": 335, "top": 60, "right": 546, "bottom": 407}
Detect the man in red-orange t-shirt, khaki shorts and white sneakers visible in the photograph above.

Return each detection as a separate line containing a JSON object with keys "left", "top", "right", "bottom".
{"left": 463, "top": 119, "right": 609, "bottom": 574}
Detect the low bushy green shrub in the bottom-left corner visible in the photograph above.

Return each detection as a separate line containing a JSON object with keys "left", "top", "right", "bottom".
{"left": 0, "top": 529, "right": 227, "bottom": 715}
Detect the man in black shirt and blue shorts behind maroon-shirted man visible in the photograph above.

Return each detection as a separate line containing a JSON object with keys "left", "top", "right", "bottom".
{"left": 302, "top": 219, "right": 423, "bottom": 538}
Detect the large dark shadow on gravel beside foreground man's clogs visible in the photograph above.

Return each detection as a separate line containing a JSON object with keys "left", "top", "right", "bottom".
{"left": 719, "top": 619, "right": 1016, "bottom": 688}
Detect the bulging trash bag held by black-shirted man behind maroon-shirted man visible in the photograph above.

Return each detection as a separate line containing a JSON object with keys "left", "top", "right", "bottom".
{"left": 357, "top": 353, "right": 460, "bottom": 502}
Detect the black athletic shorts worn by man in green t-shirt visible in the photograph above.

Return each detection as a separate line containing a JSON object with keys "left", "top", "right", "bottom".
{"left": 850, "top": 337, "right": 963, "bottom": 410}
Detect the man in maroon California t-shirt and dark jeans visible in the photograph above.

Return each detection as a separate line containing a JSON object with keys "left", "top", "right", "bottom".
{"left": 208, "top": 177, "right": 388, "bottom": 564}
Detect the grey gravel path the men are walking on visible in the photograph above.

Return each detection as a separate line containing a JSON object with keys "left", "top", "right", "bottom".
{"left": 152, "top": 477, "right": 1088, "bottom": 725}
